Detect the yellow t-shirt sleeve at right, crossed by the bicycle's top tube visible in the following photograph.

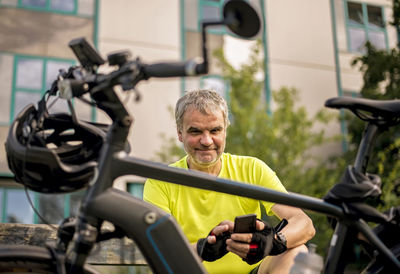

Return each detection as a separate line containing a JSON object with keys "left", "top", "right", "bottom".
{"left": 255, "top": 160, "right": 287, "bottom": 215}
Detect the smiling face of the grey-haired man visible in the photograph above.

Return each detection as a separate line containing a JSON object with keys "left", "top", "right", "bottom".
{"left": 178, "top": 107, "right": 226, "bottom": 170}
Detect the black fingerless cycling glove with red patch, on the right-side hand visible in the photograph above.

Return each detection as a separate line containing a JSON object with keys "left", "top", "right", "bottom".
{"left": 243, "top": 219, "right": 287, "bottom": 264}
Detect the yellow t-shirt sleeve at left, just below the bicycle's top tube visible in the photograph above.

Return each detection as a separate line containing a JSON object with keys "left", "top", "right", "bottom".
{"left": 143, "top": 179, "right": 171, "bottom": 214}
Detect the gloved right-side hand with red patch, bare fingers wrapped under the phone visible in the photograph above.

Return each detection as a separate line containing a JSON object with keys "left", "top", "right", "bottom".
{"left": 226, "top": 220, "right": 286, "bottom": 264}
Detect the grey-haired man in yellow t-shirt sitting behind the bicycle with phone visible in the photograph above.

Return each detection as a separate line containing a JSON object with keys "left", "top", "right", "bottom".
{"left": 144, "top": 90, "right": 315, "bottom": 273}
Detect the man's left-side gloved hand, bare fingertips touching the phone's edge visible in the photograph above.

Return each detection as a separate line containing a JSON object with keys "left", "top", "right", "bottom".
{"left": 197, "top": 221, "right": 233, "bottom": 262}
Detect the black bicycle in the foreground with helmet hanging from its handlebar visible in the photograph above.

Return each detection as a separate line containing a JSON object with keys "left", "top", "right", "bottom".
{"left": 0, "top": 1, "right": 400, "bottom": 273}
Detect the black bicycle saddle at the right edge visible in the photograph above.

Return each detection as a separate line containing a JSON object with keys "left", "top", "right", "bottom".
{"left": 325, "top": 97, "right": 400, "bottom": 120}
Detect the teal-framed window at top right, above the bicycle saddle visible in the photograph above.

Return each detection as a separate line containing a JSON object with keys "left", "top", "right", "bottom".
{"left": 345, "top": 1, "right": 388, "bottom": 53}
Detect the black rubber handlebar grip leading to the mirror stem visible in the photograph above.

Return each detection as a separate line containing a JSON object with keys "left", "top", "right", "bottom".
{"left": 143, "top": 59, "right": 208, "bottom": 78}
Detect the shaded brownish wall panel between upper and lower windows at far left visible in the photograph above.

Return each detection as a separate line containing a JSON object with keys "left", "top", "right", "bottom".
{"left": 0, "top": 7, "right": 94, "bottom": 58}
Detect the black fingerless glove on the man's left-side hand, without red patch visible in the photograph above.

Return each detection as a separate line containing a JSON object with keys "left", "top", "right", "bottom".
{"left": 197, "top": 231, "right": 231, "bottom": 262}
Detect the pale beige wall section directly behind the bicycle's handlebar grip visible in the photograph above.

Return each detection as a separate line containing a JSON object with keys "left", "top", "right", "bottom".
{"left": 98, "top": 0, "right": 181, "bottom": 159}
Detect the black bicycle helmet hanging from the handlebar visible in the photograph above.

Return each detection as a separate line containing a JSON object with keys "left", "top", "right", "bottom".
{"left": 5, "top": 103, "right": 106, "bottom": 193}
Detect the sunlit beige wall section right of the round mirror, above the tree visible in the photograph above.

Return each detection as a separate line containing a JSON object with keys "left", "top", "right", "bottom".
{"left": 266, "top": 0, "right": 337, "bottom": 113}
